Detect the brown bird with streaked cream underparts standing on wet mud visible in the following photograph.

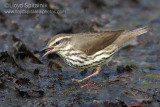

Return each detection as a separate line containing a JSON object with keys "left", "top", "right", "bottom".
{"left": 42, "top": 27, "right": 150, "bottom": 82}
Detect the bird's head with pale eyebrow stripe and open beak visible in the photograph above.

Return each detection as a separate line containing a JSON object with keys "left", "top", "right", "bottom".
{"left": 42, "top": 34, "right": 71, "bottom": 57}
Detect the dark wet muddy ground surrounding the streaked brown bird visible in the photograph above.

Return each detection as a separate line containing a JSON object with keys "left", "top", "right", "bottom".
{"left": 0, "top": 0, "right": 160, "bottom": 107}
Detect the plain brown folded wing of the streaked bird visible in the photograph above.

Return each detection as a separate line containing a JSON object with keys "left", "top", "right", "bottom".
{"left": 71, "top": 30, "right": 124, "bottom": 55}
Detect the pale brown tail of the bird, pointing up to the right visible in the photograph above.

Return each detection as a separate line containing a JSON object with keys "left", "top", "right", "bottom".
{"left": 114, "top": 27, "right": 151, "bottom": 48}
